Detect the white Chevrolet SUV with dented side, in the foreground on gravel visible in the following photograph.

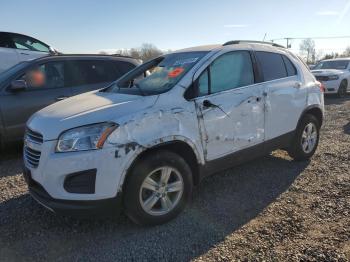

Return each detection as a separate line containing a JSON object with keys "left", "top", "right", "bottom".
{"left": 24, "top": 41, "right": 324, "bottom": 224}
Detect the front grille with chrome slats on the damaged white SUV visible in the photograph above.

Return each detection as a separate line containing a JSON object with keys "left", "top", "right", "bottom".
{"left": 24, "top": 128, "right": 44, "bottom": 168}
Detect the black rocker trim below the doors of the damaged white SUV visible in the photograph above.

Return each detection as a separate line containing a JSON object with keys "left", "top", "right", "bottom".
{"left": 199, "top": 131, "right": 295, "bottom": 180}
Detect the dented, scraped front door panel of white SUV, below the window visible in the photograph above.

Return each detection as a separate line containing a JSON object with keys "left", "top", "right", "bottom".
{"left": 196, "top": 85, "right": 264, "bottom": 160}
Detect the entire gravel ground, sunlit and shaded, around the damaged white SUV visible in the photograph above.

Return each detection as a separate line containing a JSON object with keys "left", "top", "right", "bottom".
{"left": 0, "top": 98, "right": 350, "bottom": 261}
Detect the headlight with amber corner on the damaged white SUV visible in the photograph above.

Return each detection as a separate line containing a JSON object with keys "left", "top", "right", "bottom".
{"left": 56, "top": 123, "right": 118, "bottom": 152}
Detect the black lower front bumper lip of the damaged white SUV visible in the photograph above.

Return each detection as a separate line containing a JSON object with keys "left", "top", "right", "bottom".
{"left": 23, "top": 167, "right": 122, "bottom": 218}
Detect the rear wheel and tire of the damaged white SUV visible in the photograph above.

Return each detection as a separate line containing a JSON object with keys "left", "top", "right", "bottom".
{"left": 288, "top": 114, "right": 320, "bottom": 161}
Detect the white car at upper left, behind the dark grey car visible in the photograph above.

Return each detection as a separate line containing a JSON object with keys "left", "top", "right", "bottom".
{"left": 0, "top": 32, "right": 57, "bottom": 74}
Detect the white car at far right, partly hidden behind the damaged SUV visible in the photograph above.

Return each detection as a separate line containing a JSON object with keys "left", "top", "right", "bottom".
{"left": 311, "top": 58, "right": 350, "bottom": 97}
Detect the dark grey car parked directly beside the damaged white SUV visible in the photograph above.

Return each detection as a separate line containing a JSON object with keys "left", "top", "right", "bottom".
{"left": 0, "top": 55, "right": 140, "bottom": 146}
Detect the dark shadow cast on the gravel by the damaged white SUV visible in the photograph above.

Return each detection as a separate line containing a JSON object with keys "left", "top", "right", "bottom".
{"left": 0, "top": 152, "right": 308, "bottom": 261}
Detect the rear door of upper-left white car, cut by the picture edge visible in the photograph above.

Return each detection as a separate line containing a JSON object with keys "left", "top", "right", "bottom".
{"left": 0, "top": 32, "right": 19, "bottom": 73}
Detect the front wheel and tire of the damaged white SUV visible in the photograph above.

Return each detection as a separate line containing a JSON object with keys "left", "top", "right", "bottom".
{"left": 124, "top": 150, "right": 193, "bottom": 225}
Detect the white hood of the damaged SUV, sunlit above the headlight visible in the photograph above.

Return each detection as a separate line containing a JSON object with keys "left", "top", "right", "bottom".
{"left": 27, "top": 91, "right": 158, "bottom": 140}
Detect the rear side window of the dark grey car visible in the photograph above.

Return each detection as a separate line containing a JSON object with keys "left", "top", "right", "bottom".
{"left": 66, "top": 60, "right": 122, "bottom": 86}
